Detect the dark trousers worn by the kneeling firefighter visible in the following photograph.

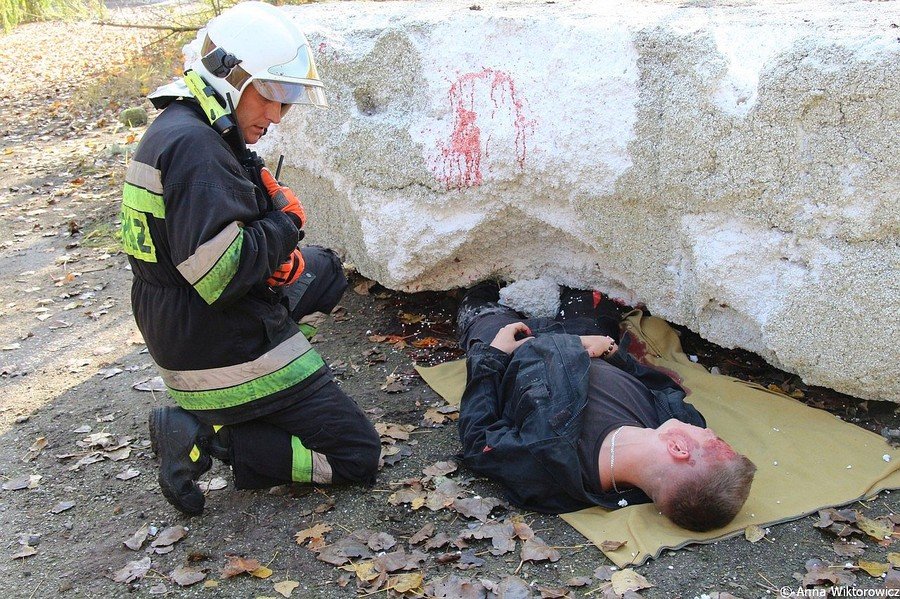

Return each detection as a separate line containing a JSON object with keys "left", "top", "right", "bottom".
{"left": 205, "top": 246, "right": 381, "bottom": 489}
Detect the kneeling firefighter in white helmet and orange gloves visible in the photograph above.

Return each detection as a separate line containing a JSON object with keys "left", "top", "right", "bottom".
{"left": 122, "top": 2, "right": 380, "bottom": 515}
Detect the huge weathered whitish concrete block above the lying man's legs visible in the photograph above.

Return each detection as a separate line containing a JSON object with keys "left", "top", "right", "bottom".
{"left": 261, "top": 0, "right": 900, "bottom": 401}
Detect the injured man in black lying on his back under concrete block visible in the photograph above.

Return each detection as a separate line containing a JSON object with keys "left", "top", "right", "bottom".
{"left": 457, "top": 283, "right": 756, "bottom": 532}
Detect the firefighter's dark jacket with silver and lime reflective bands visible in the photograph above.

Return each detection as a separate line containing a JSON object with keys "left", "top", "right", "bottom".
{"left": 121, "top": 100, "right": 328, "bottom": 424}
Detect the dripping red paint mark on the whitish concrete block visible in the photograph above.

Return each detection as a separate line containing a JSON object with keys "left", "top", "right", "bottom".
{"left": 435, "top": 69, "right": 532, "bottom": 189}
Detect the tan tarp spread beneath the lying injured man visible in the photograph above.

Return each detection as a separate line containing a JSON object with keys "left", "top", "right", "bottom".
{"left": 417, "top": 311, "right": 900, "bottom": 566}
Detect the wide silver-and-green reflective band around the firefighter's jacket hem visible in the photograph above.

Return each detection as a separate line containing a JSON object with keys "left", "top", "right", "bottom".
{"left": 159, "top": 331, "right": 325, "bottom": 410}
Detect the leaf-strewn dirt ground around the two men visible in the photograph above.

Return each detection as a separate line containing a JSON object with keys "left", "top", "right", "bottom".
{"left": 0, "top": 5, "right": 900, "bottom": 598}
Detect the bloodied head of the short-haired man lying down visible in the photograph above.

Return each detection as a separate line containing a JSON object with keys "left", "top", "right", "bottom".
{"left": 651, "top": 419, "right": 756, "bottom": 532}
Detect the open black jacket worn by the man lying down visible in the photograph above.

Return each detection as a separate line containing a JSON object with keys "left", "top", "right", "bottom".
{"left": 459, "top": 332, "right": 706, "bottom": 513}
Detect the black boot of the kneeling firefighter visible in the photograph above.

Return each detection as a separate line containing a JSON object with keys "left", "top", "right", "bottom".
{"left": 150, "top": 407, "right": 212, "bottom": 516}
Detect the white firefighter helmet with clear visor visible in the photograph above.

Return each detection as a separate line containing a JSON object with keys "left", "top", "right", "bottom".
{"left": 188, "top": 2, "right": 328, "bottom": 108}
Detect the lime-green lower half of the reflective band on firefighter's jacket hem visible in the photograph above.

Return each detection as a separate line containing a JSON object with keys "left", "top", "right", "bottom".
{"left": 168, "top": 346, "right": 325, "bottom": 410}
